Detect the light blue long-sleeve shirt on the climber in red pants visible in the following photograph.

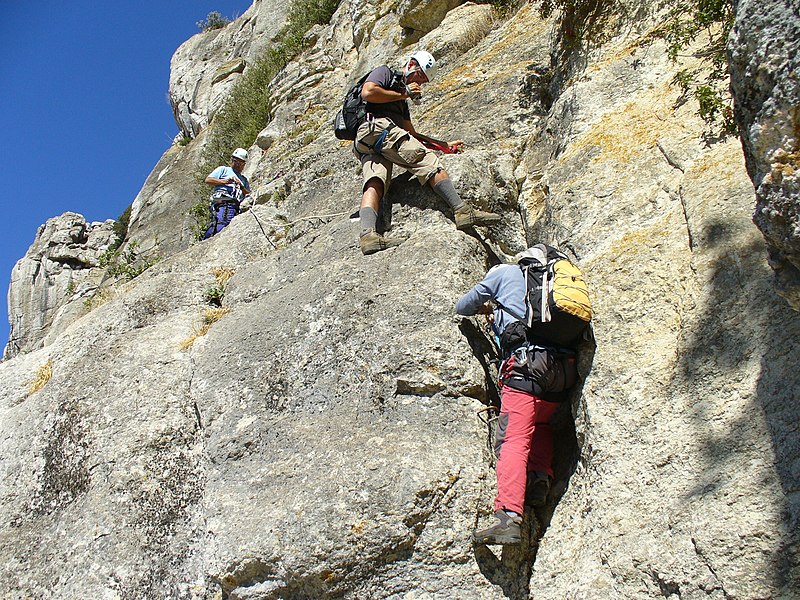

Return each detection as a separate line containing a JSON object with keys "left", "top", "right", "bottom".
{"left": 456, "top": 265, "right": 527, "bottom": 335}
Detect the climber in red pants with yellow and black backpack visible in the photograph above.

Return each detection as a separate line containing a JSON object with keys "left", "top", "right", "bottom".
{"left": 456, "top": 244, "right": 592, "bottom": 544}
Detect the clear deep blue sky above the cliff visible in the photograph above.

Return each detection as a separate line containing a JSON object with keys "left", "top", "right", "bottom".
{"left": 0, "top": 0, "right": 252, "bottom": 346}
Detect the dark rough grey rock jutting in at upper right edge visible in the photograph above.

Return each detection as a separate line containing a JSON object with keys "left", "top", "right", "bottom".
{"left": 728, "top": 0, "right": 800, "bottom": 310}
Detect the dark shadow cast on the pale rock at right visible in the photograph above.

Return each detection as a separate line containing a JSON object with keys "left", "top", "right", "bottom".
{"left": 677, "top": 221, "right": 800, "bottom": 591}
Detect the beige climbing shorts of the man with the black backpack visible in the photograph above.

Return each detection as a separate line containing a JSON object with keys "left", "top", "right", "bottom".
{"left": 353, "top": 117, "right": 443, "bottom": 193}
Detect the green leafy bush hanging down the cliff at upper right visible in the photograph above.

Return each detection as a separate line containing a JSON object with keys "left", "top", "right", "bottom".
{"left": 661, "top": 0, "right": 736, "bottom": 135}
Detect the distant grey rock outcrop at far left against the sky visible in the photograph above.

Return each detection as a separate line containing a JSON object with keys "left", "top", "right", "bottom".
{"left": 4, "top": 213, "right": 116, "bottom": 358}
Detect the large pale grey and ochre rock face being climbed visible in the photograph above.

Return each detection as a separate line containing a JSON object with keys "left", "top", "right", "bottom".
{"left": 0, "top": 1, "right": 800, "bottom": 600}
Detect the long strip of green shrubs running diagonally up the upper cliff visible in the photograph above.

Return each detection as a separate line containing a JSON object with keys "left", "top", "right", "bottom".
{"left": 194, "top": 0, "right": 340, "bottom": 238}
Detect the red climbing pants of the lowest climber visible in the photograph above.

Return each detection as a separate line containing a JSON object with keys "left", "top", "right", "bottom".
{"left": 494, "top": 385, "right": 558, "bottom": 514}
